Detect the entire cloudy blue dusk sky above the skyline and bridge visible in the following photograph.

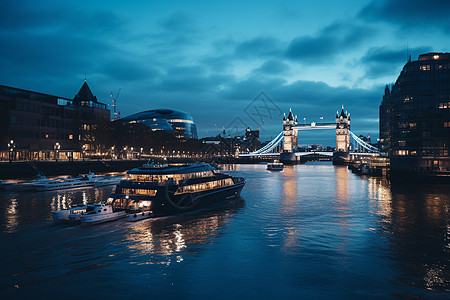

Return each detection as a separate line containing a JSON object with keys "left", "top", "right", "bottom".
{"left": 0, "top": 0, "right": 450, "bottom": 145}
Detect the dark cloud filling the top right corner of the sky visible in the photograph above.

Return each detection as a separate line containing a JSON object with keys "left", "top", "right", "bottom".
{"left": 359, "top": 0, "right": 450, "bottom": 31}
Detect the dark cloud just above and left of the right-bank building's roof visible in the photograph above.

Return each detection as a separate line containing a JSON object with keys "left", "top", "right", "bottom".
{"left": 359, "top": 47, "right": 431, "bottom": 79}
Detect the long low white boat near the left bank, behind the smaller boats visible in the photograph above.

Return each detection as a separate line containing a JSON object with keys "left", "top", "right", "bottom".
{"left": 21, "top": 173, "right": 96, "bottom": 191}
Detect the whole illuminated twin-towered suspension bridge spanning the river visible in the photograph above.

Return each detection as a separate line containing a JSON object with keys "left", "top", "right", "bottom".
{"left": 239, "top": 106, "right": 380, "bottom": 164}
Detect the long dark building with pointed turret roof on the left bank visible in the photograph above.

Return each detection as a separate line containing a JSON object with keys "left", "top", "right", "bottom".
{"left": 0, "top": 81, "right": 110, "bottom": 159}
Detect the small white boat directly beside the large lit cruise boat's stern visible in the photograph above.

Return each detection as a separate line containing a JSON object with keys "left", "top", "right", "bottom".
{"left": 80, "top": 203, "right": 126, "bottom": 226}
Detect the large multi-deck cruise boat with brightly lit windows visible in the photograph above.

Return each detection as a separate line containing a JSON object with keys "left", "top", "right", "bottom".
{"left": 106, "top": 163, "right": 245, "bottom": 221}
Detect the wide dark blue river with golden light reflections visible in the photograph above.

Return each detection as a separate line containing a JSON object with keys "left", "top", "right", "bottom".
{"left": 0, "top": 162, "right": 450, "bottom": 299}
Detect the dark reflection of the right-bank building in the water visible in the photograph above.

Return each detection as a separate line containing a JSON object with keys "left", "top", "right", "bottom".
{"left": 386, "top": 184, "right": 450, "bottom": 291}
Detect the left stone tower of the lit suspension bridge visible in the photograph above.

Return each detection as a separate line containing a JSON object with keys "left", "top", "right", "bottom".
{"left": 280, "top": 109, "right": 298, "bottom": 163}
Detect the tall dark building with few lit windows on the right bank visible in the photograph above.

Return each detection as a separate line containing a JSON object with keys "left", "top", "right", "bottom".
{"left": 380, "top": 53, "right": 450, "bottom": 175}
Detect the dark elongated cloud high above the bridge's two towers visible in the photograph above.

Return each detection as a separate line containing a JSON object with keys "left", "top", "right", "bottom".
{"left": 285, "top": 22, "right": 375, "bottom": 64}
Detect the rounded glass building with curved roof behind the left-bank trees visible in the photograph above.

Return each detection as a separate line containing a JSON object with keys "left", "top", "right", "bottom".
{"left": 121, "top": 109, "right": 197, "bottom": 140}
